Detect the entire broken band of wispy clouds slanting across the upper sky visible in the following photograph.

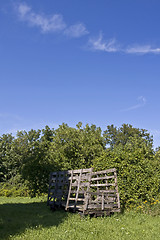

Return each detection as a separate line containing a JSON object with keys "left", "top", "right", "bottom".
{"left": 15, "top": 2, "right": 160, "bottom": 55}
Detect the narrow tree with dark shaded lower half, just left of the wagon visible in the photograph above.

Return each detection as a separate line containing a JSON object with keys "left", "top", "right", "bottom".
{"left": 21, "top": 126, "right": 53, "bottom": 195}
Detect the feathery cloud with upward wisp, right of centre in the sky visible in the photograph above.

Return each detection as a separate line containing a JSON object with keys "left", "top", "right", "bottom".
{"left": 89, "top": 33, "right": 120, "bottom": 52}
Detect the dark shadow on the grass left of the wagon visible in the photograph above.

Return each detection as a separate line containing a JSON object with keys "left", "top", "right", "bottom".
{"left": 0, "top": 202, "right": 68, "bottom": 240}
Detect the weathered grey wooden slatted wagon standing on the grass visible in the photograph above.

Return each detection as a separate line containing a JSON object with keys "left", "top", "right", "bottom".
{"left": 47, "top": 168, "right": 120, "bottom": 216}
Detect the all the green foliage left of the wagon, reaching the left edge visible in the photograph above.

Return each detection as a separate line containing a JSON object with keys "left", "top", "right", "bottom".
{"left": 0, "top": 126, "right": 52, "bottom": 195}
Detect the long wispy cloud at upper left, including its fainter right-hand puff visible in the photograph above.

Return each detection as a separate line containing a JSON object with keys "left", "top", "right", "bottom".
{"left": 15, "top": 3, "right": 88, "bottom": 38}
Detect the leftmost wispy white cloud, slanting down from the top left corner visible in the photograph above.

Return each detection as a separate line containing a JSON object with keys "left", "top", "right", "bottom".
{"left": 16, "top": 3, "right": 66, "bottom": 33}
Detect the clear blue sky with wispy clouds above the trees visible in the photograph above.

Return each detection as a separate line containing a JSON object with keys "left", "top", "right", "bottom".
{"left": 0, "top": 0, "right": 160, "bottom": 147}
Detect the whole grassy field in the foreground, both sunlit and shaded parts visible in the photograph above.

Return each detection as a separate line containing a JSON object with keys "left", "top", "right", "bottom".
{"left": 0, "top": 197, "right": 160, "bottom": 240}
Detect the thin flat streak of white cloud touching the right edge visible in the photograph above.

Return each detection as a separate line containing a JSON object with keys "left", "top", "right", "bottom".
{"left": 124, "top": 45, "right": 160, "bottom": 54}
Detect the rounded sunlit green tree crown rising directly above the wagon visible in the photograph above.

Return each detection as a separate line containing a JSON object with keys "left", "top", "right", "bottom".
{"left": 47, "top": 123, "right": 105, "bottom": 170}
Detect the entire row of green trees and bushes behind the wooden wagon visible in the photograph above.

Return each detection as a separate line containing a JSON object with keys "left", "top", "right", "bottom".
{"left": 0, "top": 122, "right": 160, "bottom": 207}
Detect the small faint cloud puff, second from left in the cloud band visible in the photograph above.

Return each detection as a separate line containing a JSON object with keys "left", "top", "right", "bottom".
{"left": 64, "top": 23, "right": 89, "bottom": 38}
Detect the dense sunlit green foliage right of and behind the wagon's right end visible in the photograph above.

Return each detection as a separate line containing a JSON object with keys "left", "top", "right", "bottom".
{"left": 93, "top": 125, "right": 160, "bottom": 207}
